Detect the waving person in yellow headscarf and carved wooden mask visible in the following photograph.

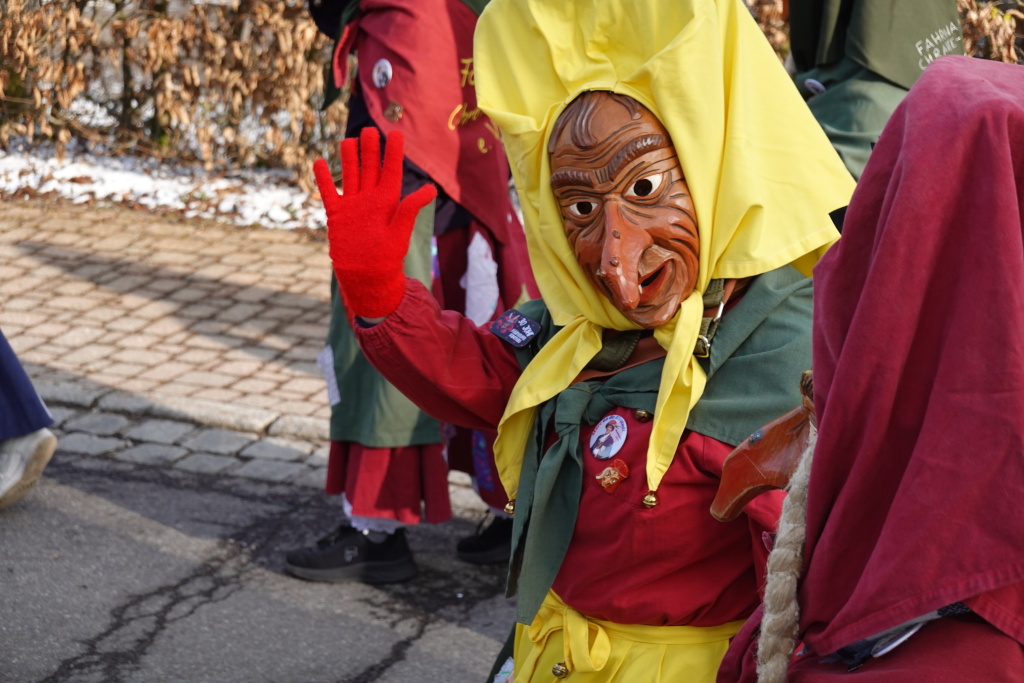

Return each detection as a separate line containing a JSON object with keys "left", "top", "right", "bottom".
{"left": 314, "top": 0, "right": 854, "bottom": 683}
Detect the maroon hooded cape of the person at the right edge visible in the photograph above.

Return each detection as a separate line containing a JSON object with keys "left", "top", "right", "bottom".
{"left": 719, "top": 56, "right": 1024, "bottom": 683}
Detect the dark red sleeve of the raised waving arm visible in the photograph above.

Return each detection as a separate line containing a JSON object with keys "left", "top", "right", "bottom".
{"left": 355, "top": 279, "right": 520, "bottom": 430}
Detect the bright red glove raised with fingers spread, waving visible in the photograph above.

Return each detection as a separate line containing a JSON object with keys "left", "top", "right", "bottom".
{"left": 313, "top": 128, "right": 437, "bottom": 317}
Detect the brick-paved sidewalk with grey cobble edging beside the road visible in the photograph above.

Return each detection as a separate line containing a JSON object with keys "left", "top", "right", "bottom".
{"left": 0, "top": 197, "right": 483, "bottom": 505}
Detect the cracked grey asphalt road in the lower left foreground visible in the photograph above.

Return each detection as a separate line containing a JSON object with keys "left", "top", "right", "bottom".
{"left": 0, "top": 451, "right": 513, "bottom": 683}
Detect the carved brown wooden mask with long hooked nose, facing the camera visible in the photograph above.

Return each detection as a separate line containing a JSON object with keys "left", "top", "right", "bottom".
{"left": 548, "top": 91, "right": 700, "bottom": 329}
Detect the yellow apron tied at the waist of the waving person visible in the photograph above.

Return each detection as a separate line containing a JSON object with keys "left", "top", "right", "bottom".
{"left": 512, "top": 591, "right": 743, "bottom": 683}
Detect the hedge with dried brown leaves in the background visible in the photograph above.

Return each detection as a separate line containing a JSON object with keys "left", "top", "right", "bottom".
{"left": 0, "top": 0, "right": 1024, "bottom": 189}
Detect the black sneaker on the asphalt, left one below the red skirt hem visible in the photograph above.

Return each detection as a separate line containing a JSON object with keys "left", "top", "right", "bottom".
{"left": 285, "top": 524, "right": 417, "bottom": 584}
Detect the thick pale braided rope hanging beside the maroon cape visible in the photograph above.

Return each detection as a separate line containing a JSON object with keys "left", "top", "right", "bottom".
{"left": 758, "top": 425, "right": 818, "bottom": 683}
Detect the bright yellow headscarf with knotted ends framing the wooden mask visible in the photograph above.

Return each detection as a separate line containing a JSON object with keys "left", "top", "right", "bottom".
{"left": 474, "top": 0, "right": 854, "bottom": 499}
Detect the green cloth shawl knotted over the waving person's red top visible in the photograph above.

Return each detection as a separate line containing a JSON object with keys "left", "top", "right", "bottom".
{"left": 508, "top": 266, "right": 811, "bottom": 624}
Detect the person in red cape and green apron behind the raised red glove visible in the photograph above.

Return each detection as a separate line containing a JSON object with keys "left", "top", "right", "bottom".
{"left": 286, "top": 0, "right": 537, "bottom": 583}
